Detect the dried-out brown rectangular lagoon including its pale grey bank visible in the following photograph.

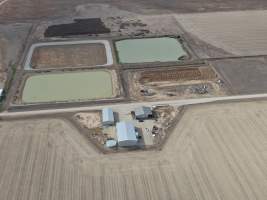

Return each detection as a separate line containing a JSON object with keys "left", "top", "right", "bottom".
{"left": 24, "top": 40, "right": 113, "bottom": 70}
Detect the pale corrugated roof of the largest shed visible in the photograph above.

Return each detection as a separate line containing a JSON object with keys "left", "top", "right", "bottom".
{"left": 116, "top": 122, "right": 137, "bottom": 142}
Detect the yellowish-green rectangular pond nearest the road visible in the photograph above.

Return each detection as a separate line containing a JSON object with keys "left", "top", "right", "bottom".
{"left": 22, "top": 71, "right": 113, "bottom": 103}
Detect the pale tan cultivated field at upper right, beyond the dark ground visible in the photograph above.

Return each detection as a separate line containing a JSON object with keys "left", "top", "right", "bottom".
{"left": 176, "top": 11, "right": 267, "bottom": 56}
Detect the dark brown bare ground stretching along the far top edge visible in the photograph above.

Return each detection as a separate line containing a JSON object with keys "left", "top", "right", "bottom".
{"left": 0, "top": 0, "right": 267, "bottom": 20}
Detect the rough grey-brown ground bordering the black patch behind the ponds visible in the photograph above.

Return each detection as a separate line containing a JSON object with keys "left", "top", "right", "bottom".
{"left": 30, "top": 7, "right": 181, "bottom": 39}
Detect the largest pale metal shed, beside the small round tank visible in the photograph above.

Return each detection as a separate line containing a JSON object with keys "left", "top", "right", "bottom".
{"left": 116, "top": 122, "right": 137, "bottom": 147}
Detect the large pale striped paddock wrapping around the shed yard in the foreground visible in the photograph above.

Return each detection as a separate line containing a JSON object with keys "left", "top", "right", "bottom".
{"left": 0, "top": 102, "right": 267, "bottom": 200}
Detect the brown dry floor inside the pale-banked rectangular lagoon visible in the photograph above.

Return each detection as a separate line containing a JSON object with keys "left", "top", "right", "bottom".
{"left": 31, "top": 44, "right": 107, "bottom": 69}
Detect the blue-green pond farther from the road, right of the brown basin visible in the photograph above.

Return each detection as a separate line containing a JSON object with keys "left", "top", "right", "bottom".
{"left": 115, "top": 37, "right": 187, "bottom": 63}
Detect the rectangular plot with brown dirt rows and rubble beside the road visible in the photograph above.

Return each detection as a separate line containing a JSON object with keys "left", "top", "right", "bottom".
{"left": 124, "top": 67, "right": 226, "bottom": 100}
